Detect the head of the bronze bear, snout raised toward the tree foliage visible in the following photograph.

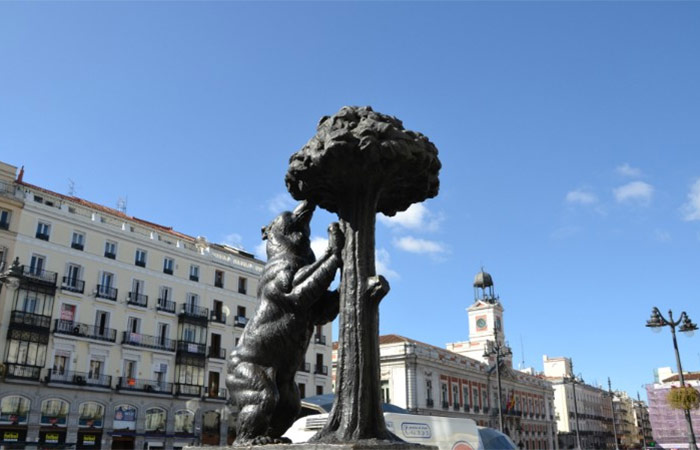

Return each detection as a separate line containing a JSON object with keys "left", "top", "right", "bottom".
{"left": 261, "top": 201, "right": 316, "bottom": 261}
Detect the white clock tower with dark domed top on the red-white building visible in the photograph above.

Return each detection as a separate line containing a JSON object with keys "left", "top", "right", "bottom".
{"left": 447, "top": 269, "right": 512, "bottom": 367}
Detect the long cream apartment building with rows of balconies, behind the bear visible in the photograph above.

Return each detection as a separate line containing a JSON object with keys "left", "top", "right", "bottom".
{"left": 0, "top": 163, "right": 331, "bottom": 449}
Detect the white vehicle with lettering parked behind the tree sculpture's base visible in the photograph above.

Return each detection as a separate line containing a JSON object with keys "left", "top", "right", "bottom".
{"left": 285, "top": 394, "right": 518, "bottom": 450}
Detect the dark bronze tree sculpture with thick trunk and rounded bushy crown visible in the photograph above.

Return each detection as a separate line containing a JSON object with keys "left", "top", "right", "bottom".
{"left": 285, "top": 107, "right": 441, "bottom": 443}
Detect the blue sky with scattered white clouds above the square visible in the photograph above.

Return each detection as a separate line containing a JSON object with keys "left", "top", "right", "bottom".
{"left": 0, "top": 2, "right": 700, "bottom": 395}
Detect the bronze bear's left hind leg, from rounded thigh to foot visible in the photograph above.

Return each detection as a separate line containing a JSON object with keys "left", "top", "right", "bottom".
{"left": 226, "top": 363, "right": 279, "bottom": 444}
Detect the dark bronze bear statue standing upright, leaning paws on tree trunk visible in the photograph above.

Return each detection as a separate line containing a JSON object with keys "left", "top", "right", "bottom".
{"left": 226, "top": 202, "right": 344, "bottom": 445}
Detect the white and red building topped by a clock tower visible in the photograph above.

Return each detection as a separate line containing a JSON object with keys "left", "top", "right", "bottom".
{"left": 334, "top": 271, "right": 558, "bottom": 449}
